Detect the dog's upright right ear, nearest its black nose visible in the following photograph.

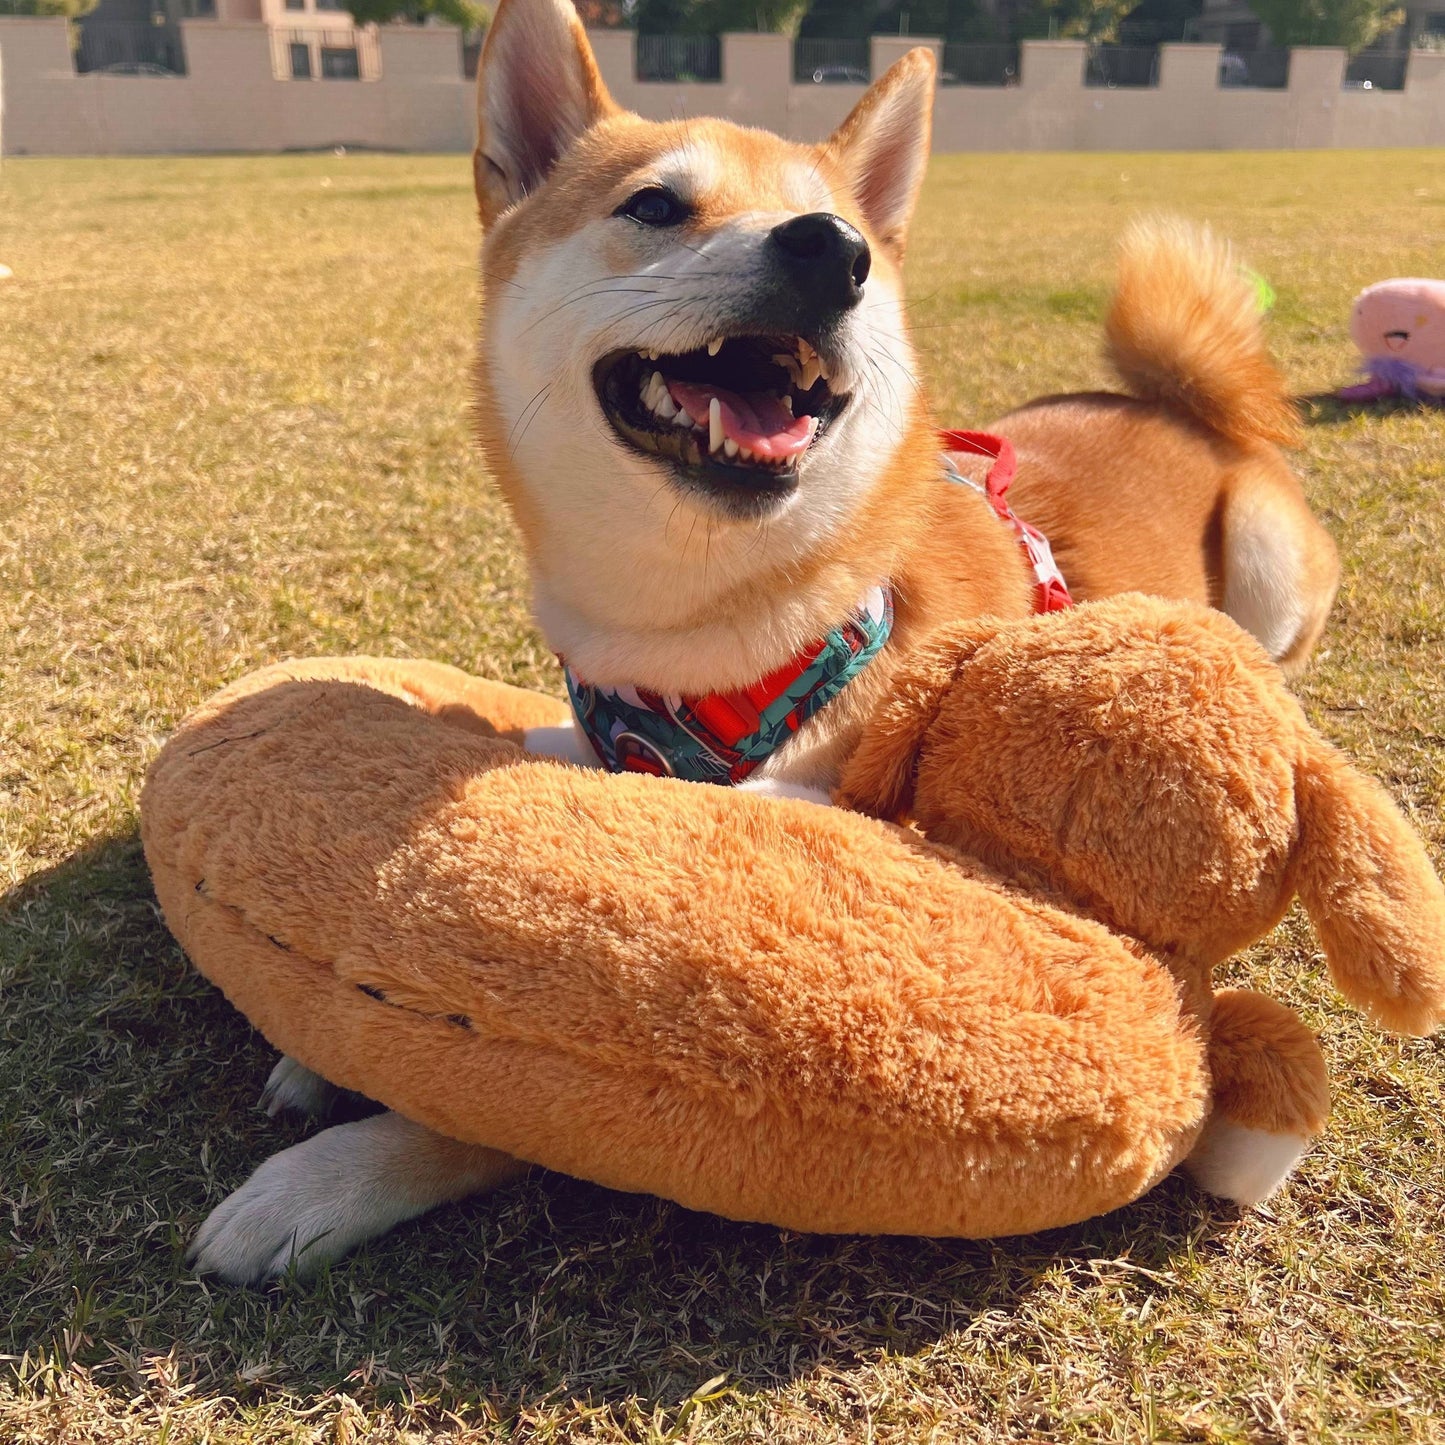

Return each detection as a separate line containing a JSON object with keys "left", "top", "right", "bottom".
{"left": 827, "top": 46, "right": 938, "bottom": 260}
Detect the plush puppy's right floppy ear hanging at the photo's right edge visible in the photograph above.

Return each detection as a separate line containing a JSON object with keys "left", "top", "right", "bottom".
{"left": 1295, "top": 740, "right": 1445, "bottom": 1035}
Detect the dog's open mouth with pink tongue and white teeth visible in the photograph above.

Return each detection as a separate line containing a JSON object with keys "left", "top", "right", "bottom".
{"left": 592, "top": 337, "right": 848, "bottom": 499}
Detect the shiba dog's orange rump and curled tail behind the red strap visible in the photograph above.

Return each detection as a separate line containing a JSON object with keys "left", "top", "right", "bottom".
{"left": 999, "top": 220, "right": 1340, "bottom": 670}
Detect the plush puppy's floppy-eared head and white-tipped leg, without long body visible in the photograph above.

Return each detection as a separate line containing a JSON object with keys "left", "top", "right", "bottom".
{"left": 840, "top": 595, "right": 1445, "bottom": 1202}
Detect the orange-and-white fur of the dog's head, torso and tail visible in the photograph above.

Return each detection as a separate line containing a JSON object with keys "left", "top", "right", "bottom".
{"left": 475, "top": 0, "right": 1337, "bottom": 792}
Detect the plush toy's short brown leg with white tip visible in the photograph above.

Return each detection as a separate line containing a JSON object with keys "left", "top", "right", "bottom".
{"left": 1185, "top": 990, "right": 1329, "bottom": 1205}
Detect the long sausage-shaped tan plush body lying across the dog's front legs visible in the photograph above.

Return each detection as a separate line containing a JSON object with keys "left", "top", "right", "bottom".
{"left": 145, "top": 659, "right": 1208, "bottom": 1235}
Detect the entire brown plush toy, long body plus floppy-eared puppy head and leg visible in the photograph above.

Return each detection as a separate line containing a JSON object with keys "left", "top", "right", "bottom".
{"left": 142, "top": 597, "right": 1445, "bottom": 1277}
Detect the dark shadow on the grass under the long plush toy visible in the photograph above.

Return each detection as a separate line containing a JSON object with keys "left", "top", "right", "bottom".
{"left": 0, "top": 834, "right": 1228, "bottom": 1418}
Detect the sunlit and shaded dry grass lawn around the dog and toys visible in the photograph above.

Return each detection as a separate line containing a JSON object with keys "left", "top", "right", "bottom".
{"left": 0, "top": 152, "right": 1445, "bottom": 1445}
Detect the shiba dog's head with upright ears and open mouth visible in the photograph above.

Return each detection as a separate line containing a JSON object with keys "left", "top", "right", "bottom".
{"left": 477, "top": 0, "right": 933, "bottom": 615}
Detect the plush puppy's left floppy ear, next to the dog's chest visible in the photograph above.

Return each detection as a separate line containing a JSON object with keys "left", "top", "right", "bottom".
{"left": 834, "top": 621, "right": 996, "bottom": 818}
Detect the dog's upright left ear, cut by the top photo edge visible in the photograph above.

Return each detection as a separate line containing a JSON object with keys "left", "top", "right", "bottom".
{"left": 473, "top": 0, "right": 617, "bottom": 225}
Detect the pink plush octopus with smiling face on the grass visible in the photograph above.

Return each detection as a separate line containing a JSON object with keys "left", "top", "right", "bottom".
{"left": 1338, "top": 277, "right": 1445, "bottom": 403}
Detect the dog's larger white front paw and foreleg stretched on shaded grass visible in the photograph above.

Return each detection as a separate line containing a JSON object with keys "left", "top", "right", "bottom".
{"left": 186, "top": 1111, "right": 529, "bottom": 1285}
